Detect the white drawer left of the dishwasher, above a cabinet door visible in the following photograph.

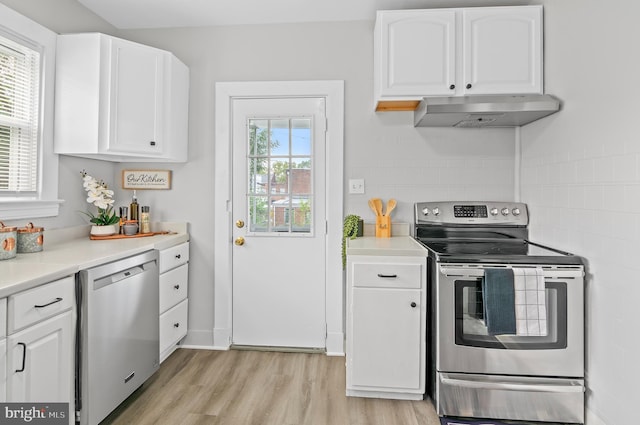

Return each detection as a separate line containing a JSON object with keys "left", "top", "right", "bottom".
{"left": 7, "top": 276, "right": 74, "bottom": 334}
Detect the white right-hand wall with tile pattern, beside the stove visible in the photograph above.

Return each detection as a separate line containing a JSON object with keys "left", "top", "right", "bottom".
{"left": 522, "top": 0, "right": 640, "bottom": 425}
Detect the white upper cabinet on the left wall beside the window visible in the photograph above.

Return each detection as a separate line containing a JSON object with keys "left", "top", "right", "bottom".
{"left": 55, "top": 33, "right": 189, "bottom": 162}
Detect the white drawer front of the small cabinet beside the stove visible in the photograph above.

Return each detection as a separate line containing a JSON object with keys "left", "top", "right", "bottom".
{"left": 352, "top": 263, "right": 422, "bottom": 289}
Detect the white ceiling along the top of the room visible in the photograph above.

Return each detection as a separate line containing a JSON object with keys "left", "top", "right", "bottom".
{"left": 78, "top": 0, "right": 531, "bottom": 29}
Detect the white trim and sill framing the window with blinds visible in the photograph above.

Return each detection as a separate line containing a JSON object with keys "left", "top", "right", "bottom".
{"left": 0, "top": 4, "right": 64, "bottom": 220}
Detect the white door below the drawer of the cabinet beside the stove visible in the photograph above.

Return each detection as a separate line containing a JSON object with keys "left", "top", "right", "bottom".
{"left": 348, "top": 288, "right": 424, "bottom": 389}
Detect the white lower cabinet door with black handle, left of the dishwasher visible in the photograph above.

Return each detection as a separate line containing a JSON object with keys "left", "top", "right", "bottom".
{"left": 7, "top": 311, "right": 73, "bottom": 402}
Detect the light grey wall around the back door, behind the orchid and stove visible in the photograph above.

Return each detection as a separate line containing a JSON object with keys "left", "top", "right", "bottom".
{"left": 0, "top": 0, "right": 514, "bottom": 364}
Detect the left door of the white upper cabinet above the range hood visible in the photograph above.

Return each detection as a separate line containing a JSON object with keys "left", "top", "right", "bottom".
{"left": 376, "top": 10, "right": 456, "bottom": 96}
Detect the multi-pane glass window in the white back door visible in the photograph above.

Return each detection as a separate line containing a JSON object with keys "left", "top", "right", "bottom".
{"left": 247, "top": 117, "right": 313, "bottom": 235}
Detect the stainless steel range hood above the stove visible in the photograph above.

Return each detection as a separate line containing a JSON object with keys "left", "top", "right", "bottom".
{"left": 414, "top": 94, "right": 560, "bottom": 128}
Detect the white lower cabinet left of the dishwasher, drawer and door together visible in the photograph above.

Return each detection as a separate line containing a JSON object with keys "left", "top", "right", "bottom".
{"left": 0, "top": 276, "right": 75, "bottom": 424}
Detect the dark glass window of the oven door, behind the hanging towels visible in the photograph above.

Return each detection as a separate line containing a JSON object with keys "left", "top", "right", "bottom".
{"left": 455, "top": 279, "right": 567, "bottom": 350}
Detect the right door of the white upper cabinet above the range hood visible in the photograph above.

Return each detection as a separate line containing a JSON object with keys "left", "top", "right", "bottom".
{"left": 462, "top": 6, "right": 543, "bottom": 94}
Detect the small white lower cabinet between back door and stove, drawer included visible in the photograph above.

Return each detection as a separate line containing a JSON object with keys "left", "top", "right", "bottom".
{"left": 346, "top": 255, "right": 426, "bottom": 400}
